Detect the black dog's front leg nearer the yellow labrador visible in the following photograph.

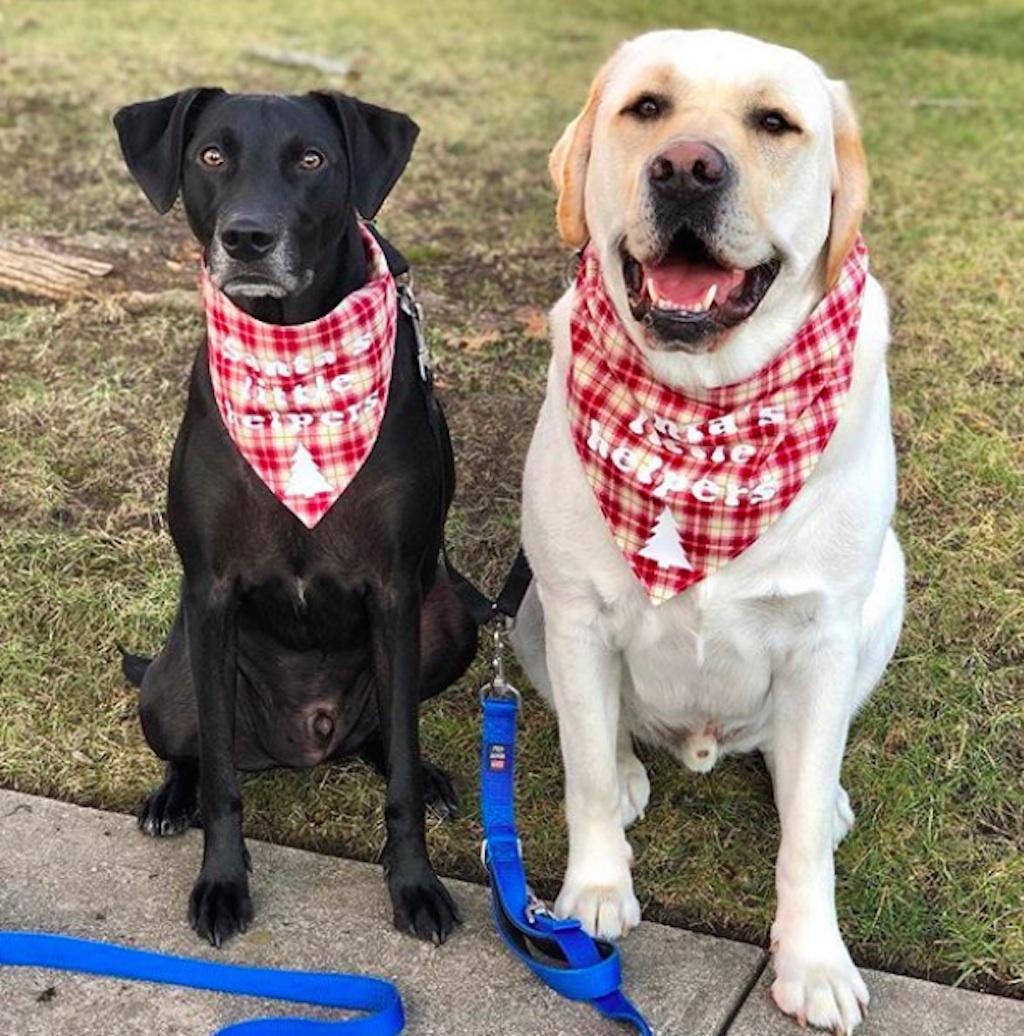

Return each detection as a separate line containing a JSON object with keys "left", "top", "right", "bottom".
{"left": 371, "top": 580, "right": 460, "bottom": 943}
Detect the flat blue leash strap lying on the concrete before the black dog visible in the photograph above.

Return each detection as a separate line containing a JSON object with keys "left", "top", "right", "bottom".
{"left": 0, "top": 931, "right": 405, "bottom": 1036}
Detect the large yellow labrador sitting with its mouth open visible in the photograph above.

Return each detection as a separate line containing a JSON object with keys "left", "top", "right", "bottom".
{"left": 515, "top": 30, "right": 904, "bottom": 1032}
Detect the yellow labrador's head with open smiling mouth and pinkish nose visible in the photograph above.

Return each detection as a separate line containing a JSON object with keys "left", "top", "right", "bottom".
{"left": 550, "top": 30, "right": 867, "bottom": 353}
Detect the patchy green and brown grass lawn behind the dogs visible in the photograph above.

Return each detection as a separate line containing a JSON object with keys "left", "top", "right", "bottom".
{"left": 0, "top": 0, "right": 1024, "bottom": 995}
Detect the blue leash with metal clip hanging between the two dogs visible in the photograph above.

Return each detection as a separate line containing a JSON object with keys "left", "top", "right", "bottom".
{"left": 480, "top": 681, "right": 654, "bottom": 1036}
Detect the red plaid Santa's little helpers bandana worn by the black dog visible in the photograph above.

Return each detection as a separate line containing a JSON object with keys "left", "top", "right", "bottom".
{"left": 200, "top": 227, "right": 398, "bottom": 528}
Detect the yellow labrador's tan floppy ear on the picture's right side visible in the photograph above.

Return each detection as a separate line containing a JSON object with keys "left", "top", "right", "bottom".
{"left": 825, "top": 80, "right": 867, "bottom": 290}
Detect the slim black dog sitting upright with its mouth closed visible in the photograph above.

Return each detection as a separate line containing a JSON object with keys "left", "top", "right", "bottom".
{"left": 114, "top": 89, "right": 477, "bottom": 945}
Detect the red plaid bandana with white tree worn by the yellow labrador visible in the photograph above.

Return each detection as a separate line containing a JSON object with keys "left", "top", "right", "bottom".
{"left": 567, "top": 238, "right": 867, "bottom": 604}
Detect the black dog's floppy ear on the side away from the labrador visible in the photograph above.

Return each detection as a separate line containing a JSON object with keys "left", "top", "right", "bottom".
{"left": 114, "top": 86, "right": 224, "bottom": 212}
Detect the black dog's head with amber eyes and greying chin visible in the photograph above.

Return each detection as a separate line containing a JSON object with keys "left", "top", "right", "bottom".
{"left": 114, "top": 87, "right": 419, "bottom": 322}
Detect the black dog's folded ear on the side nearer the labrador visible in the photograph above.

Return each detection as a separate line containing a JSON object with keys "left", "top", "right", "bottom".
{"left": 313, "top": 90, "right": 420, "bottom": 220}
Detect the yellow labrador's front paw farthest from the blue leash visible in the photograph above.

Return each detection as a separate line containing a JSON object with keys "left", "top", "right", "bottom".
{"left": 771, "top": 930, "right": 871, "bottom": 1036}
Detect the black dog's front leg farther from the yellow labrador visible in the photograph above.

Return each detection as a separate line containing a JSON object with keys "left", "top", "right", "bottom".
{"left": 184, "top": 582, "right": 253, "bottom": 946}
